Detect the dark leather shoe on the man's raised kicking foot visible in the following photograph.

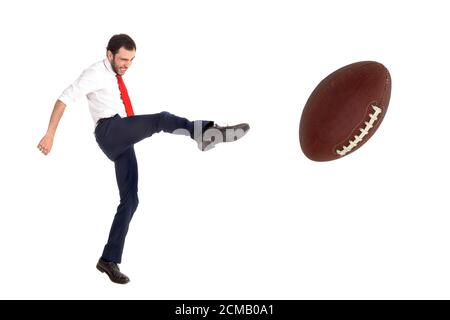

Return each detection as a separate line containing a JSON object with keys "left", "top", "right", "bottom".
{"left": 198, "top": 123, "right": 250, "bottom": 151}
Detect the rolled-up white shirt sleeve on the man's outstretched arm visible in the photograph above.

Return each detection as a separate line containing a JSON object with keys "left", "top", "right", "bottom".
{"left": 58, "top": 69, "right": 101, "bottom": 105}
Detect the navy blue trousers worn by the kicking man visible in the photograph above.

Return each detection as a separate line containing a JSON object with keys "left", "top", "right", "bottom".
{"left": 95, "top": 112, "right": 214, "bottom": 263}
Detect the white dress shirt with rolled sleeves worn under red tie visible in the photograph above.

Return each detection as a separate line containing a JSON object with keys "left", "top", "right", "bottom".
{"left": 58, "top": 59, "right": 127, "bottom": 124}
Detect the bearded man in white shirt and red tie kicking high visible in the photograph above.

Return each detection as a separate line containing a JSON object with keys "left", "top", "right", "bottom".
{"left": 38, "top": 34, "right": 250, "bottom": 284}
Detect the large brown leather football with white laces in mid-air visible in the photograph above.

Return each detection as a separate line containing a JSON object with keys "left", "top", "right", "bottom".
{"left": 299, "top": 61, "right": 391, "bottom": 161}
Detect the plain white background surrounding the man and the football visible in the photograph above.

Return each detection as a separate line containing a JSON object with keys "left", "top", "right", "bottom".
{"left": 0, "top": 0, "right": 450, "bottom": 299}
